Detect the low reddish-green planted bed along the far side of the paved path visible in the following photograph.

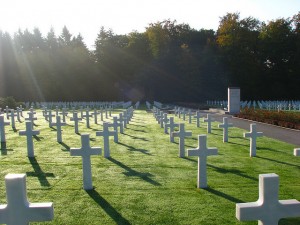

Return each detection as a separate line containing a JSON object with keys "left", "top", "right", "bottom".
{"left": 237, "top": 108, "right": 300, "bottom": 130}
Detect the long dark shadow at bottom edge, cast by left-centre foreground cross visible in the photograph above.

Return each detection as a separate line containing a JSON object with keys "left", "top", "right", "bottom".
{"left": 86, "top": 190, "right": 130, "bottom": 225}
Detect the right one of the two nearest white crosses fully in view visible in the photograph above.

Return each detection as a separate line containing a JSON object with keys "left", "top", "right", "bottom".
{"left": 187, "top": 135, "right": 218, "bottom": 188}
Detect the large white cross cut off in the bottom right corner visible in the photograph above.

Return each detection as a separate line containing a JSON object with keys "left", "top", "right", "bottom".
{"left": 236, "top": 173, "right": 300, "bottom": 225}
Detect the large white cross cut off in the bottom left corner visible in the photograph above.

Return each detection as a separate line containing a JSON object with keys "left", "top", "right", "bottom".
{"left": 0, "top": 174, "right": 54, "bottom": 225}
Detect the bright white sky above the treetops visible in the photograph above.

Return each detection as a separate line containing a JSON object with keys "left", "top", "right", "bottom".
{"left": 0, "top": 0, "right": 300, "bottom": 48}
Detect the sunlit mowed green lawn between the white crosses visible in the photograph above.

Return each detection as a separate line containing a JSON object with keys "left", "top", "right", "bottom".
{"left": 0, "top": 110, "right": 300, "bottom": 225}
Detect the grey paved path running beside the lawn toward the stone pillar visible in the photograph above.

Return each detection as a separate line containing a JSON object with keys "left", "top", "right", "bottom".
{"left": 202, "top": 111, "right": 300, "bottom": 147}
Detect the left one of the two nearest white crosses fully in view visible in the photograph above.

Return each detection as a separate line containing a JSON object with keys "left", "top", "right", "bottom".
{"left": 70, "top": 134, "right": 101, "bottom": 190}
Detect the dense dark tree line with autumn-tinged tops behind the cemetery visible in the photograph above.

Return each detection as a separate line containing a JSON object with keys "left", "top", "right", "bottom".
{"left": 0, "top": 12, "right": 300, "bottom": 102}
